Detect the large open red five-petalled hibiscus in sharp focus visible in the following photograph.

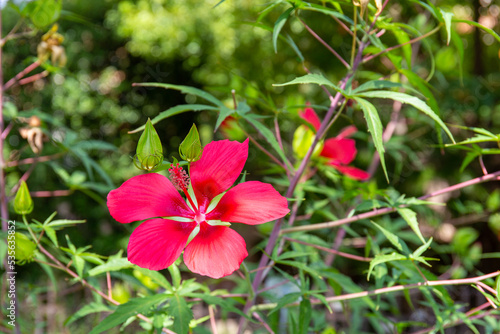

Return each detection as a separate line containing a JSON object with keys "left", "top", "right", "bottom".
{"left": 108, "top": 139, "right": 289, "bottom": 278}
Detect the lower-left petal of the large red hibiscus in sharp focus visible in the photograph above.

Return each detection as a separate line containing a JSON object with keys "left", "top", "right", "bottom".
{"left": 127, "top": 219, "right": 196, "bottom": 270}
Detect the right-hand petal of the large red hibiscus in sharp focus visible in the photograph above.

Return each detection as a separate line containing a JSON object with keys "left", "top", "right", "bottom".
{"left": 207, "top": 181, "right": 290, "bottom": 225}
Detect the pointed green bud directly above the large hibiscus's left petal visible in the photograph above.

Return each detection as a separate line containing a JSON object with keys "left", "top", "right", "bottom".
{"left": 134, "top": 118, "right": 163, "bottom": 171}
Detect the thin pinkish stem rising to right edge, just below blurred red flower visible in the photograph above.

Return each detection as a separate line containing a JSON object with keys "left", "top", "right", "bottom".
{"left": 280, "top": 171, "right": 500, "bottom": 234}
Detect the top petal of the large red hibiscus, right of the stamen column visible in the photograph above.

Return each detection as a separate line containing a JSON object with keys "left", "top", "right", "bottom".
{"left": 191, "top": 139, "right": 248, "bottom": 206}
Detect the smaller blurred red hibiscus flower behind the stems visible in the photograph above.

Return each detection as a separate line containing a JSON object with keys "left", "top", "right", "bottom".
{"left": 299, "top": 107, "right": 370, "bottom": 180}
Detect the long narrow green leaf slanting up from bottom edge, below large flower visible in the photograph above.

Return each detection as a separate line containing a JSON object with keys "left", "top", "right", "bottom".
{"left": 89, "top": 294, "right": 167, "bottom": 334}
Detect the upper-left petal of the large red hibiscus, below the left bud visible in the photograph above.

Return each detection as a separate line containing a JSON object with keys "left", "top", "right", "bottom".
{"left": 108, "top": 173, "right": 192, "bottom": 223}
